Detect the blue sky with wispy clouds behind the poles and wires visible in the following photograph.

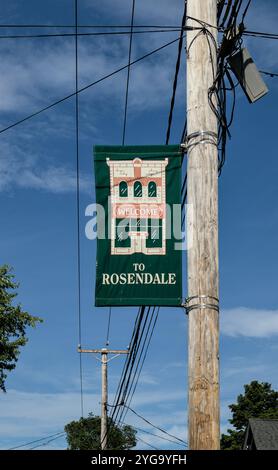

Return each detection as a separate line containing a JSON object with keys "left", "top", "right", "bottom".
{"left": 0, "top": 0, "right": 278, "bottom": 449}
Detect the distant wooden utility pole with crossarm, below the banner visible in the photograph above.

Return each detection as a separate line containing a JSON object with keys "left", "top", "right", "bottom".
{"left": 78, "top": 348, "right": 129, "bottom": 450}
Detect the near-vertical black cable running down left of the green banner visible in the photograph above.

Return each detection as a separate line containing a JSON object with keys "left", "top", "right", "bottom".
{"left": 74, "top": 0, "right": 84, "bottom": 418}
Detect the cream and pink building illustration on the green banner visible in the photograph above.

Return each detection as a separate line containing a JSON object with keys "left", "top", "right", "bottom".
{"left": 106, "top": 158, "right": 168, "bottom": 255}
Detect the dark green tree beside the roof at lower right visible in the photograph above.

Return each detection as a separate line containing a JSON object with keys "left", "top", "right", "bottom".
{"left": 221, "top": 380, "right": 278, "bottom": 450}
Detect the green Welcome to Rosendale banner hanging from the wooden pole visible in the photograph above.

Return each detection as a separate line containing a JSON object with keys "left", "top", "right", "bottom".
{"left": 94, "top": 145, "right": 182, "bottom": 306}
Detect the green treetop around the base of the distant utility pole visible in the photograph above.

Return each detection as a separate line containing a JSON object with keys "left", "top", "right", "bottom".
{"left": 65, "top": 413, "right": 136, "bottom": 450}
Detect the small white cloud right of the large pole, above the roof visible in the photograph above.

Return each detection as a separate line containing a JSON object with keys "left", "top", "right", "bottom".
{"left": 220, "top": 307, "right": 278, "bottom": 338}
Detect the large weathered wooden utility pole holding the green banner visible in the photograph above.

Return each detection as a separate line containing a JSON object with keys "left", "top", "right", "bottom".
{"left": 185, "top": 0, "right": 219, "bottom": 450}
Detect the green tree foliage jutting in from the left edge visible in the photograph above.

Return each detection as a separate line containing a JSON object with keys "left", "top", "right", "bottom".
{"left": 0, "top": 265, "right": 42, "bottom": 392}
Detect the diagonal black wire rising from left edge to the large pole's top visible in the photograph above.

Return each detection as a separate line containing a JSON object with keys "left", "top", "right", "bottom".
{"left": 0, "top": 34, "right": 185, "bottom": 134}
